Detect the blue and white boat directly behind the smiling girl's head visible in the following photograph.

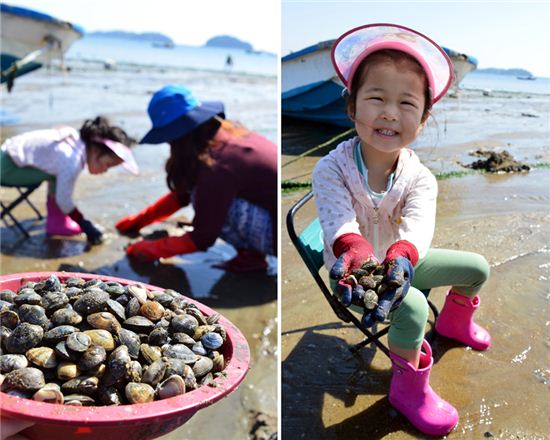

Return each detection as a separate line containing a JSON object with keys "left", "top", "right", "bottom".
{"left": 281, "top": 40, "right": 477, "bottom": 127}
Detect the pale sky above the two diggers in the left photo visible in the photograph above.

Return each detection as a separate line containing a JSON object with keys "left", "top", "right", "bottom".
{"left": 8, "top": 0, "right": 281, "bottom": 53}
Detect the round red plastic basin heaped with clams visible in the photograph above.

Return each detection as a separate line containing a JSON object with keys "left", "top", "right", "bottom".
{"left": 0, "top": 272, "right": 250, "bottom": 440}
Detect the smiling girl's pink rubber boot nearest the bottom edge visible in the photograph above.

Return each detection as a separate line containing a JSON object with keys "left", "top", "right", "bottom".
{"left": 389, "top": 340, "right": 458, "bottom": 435}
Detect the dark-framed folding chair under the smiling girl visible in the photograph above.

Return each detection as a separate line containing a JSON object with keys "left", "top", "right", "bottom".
{"left": 286, "top": 191, "right": 439, "bottom": 357}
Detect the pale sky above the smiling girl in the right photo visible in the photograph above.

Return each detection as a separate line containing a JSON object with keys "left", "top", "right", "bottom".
{"left": 281, "top": 0, "right": 550, "bottom": 77}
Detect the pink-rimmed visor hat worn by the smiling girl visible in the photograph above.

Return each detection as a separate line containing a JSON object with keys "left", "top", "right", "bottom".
{"left": 331, "top": 23, "right": 453, "bottom": 104}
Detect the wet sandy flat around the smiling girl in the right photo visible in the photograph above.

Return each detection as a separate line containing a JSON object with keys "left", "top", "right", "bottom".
{"left": 281, "top": 87, "right": 550, "bottom": 439}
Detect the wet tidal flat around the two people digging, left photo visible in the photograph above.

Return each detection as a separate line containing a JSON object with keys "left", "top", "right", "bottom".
{"left": 0, "top": 68, "right": 278, "bottom": 440}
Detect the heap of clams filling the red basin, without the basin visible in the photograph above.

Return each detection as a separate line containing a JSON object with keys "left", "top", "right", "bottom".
{"left": 0, "top": 275, "right": 226, "bottom": 406}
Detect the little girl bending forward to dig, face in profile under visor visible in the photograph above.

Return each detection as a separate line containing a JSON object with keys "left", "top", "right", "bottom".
{"left": 0, "top": 116, "right": 138, "bottom": 244}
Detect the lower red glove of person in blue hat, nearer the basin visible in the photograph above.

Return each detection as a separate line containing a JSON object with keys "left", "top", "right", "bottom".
{"left": 126, "top": 234, "right": 198, "bottom": 261}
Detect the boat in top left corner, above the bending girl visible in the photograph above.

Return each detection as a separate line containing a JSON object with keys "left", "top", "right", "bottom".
{"left": 0, "top": 3, "right": 84, "bottom": 91}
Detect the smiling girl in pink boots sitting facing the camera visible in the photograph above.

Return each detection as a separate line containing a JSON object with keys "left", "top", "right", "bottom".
{"left": 313, "top": 24, "right": 491, "bottom": 435}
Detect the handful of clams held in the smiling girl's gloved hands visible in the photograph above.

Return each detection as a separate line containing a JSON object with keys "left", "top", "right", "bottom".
{"left": 344, "top": 261, "right": 404, "bottom": 312}
